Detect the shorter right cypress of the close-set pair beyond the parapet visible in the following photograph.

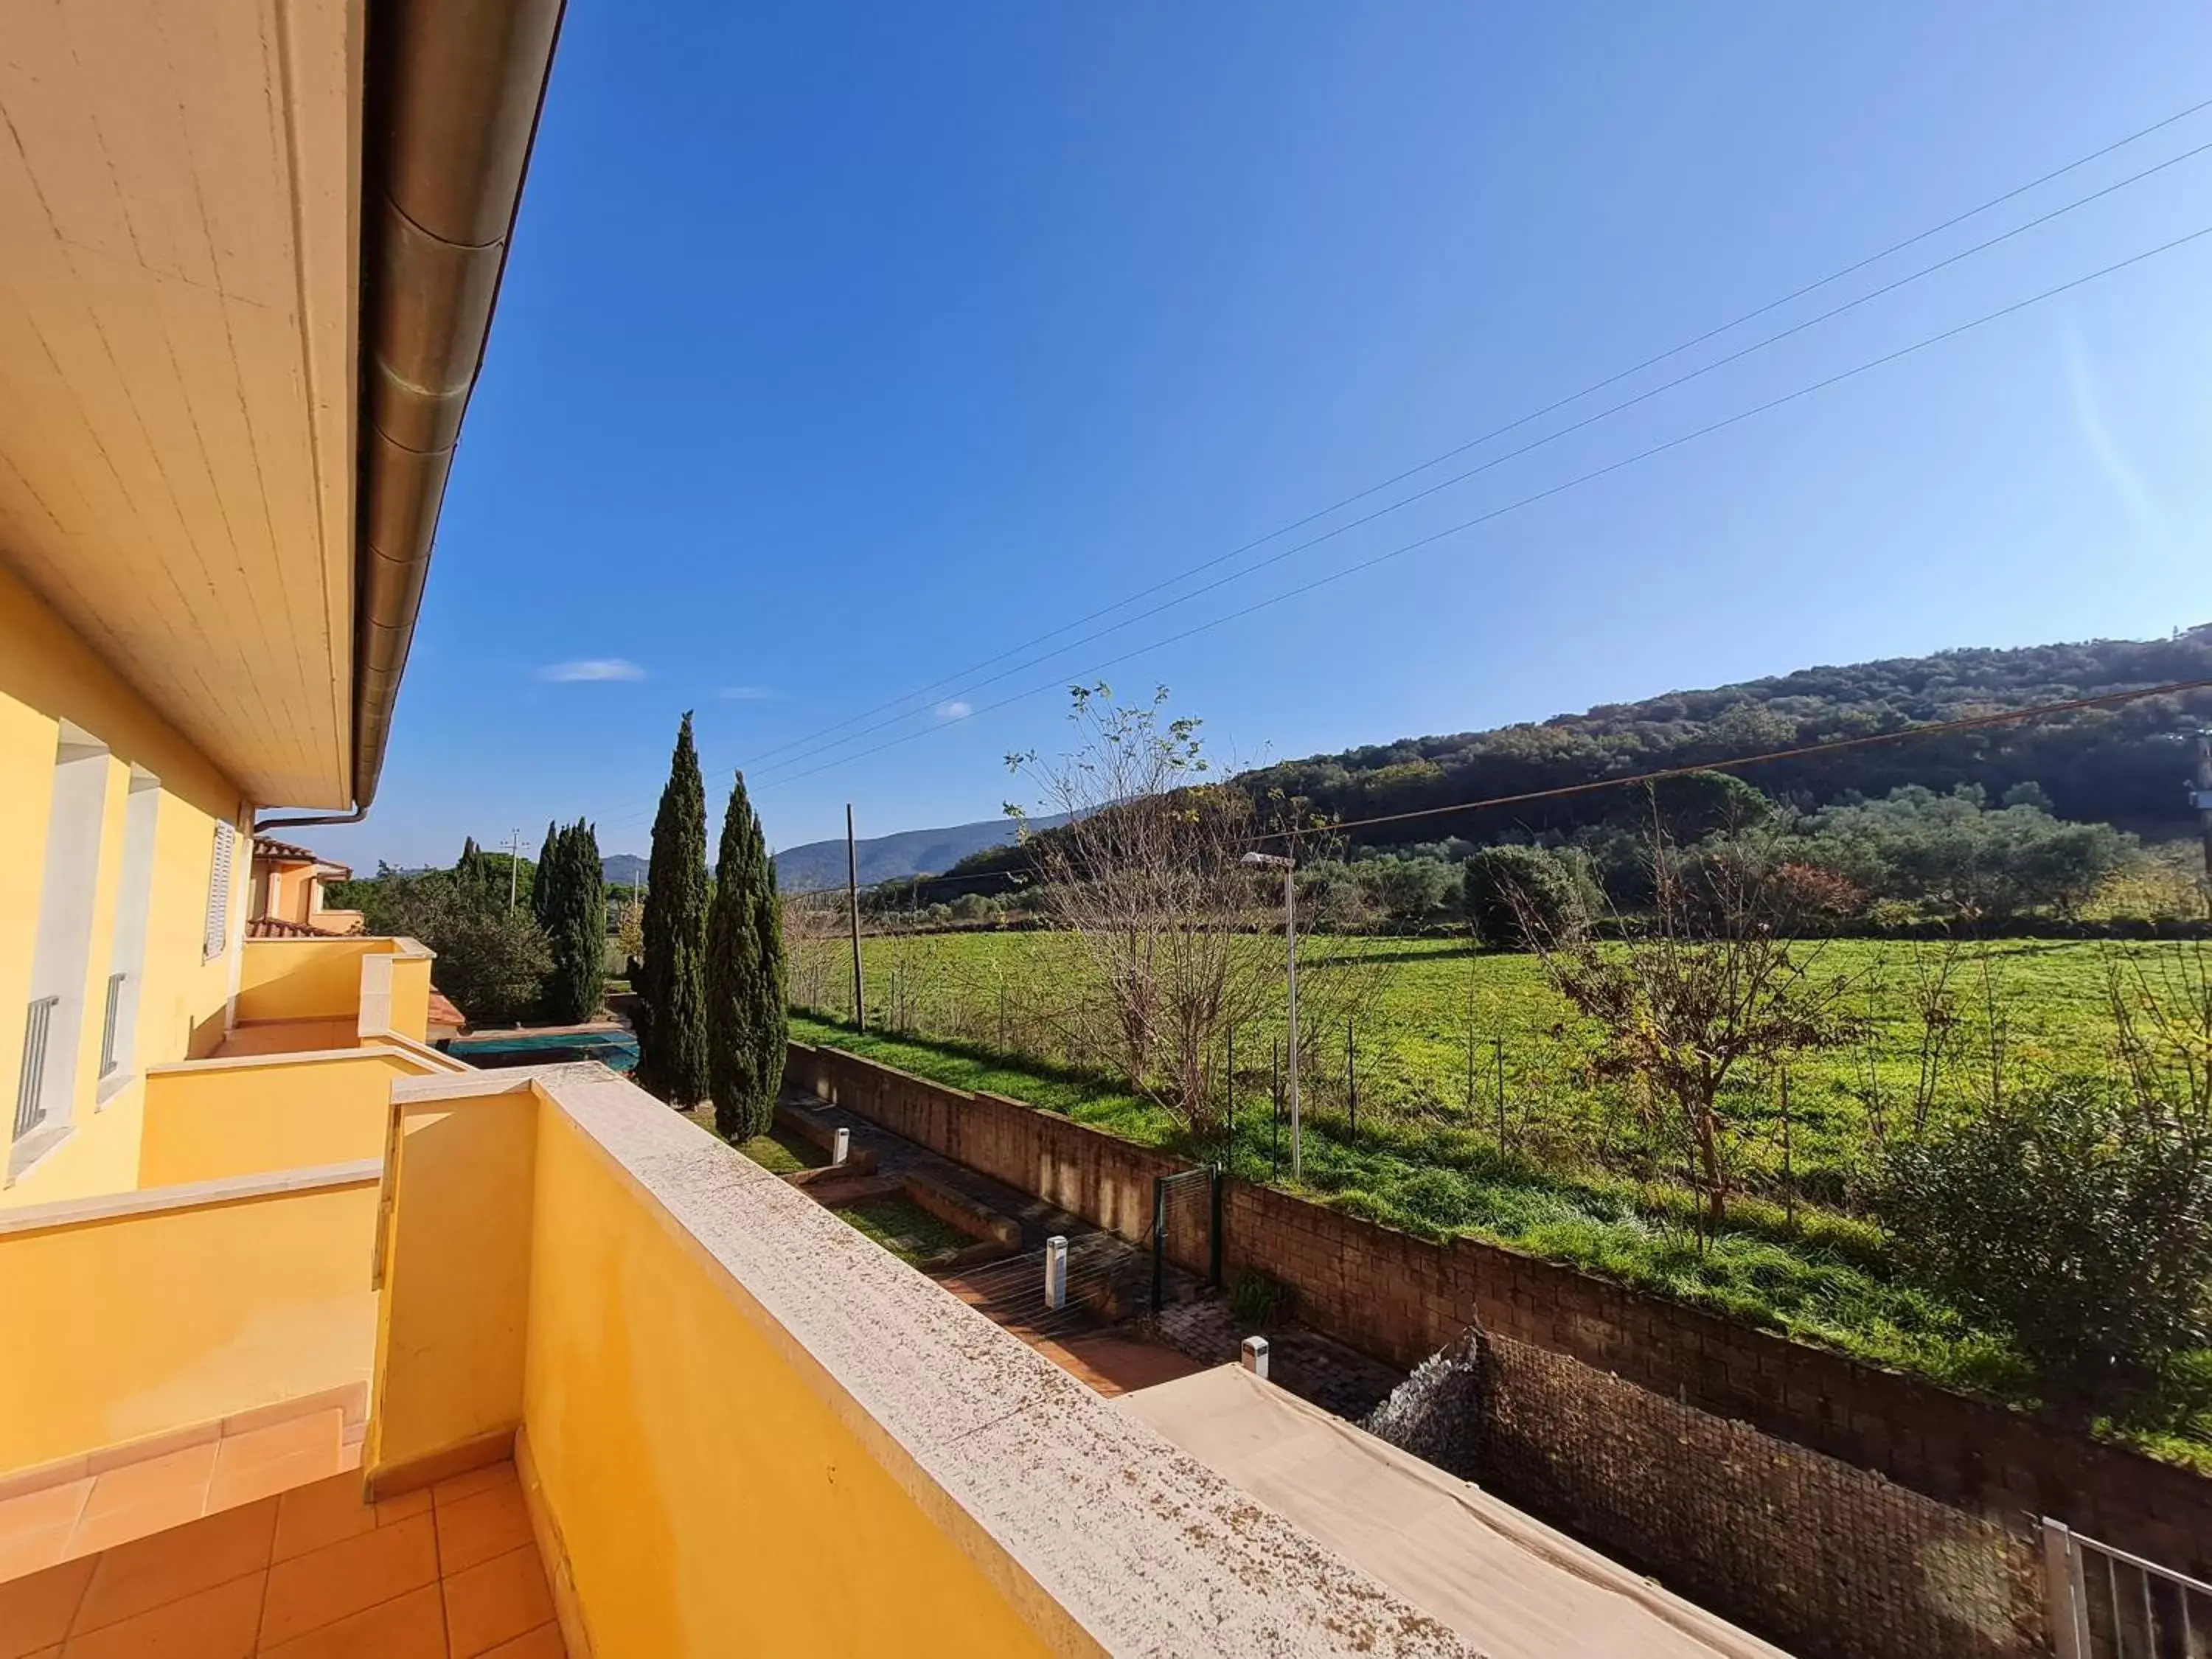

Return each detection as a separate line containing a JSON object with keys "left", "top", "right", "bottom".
{"left": 706, "top": 772, "right": 787, "bottom": 1141}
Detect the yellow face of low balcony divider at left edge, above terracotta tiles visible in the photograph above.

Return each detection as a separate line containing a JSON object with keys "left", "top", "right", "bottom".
{"left": 0, "top": 1183, "right": 376, "bottom": 1473}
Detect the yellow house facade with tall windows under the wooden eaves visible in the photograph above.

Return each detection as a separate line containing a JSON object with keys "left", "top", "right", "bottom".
{"left": 0, "top": 568, "right": 250, "bottom": 1208}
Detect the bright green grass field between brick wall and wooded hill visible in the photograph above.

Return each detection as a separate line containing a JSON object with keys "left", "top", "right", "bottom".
{"left": 792, "top": 933, "right": 2212, "bottom": 1471}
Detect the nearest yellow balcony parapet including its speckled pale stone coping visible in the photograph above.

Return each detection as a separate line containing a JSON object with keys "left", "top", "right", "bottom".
{"left": 363, "top": 1066, "right": 1464, "bottom": 1659}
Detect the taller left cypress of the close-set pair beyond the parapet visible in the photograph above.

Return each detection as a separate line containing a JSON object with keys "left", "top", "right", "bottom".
{"left": 637, "top": 710, "right": 706, "bottom": 1106}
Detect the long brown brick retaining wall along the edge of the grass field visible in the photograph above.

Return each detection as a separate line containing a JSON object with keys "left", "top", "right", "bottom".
{"left": 785, "top": 1042, "right": 2212, "bottom": 1577}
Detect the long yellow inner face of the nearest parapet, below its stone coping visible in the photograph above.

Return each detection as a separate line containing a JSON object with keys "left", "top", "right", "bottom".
{"left": 518, "top": 1104, "right": 1051, "bottom": 1659}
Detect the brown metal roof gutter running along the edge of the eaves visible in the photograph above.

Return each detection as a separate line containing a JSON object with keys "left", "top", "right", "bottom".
{"left": 257, "top": 0, "right": 562, "bottom": 830}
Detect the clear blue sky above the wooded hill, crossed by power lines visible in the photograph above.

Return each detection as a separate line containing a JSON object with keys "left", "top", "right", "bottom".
{"left": 316, "top": 0, "right": 2212, "bottom": 867}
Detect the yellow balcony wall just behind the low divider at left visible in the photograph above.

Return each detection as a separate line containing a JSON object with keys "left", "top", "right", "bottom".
{"left": 131, "top": 1048, "right": 429, "bottom": 1186}
